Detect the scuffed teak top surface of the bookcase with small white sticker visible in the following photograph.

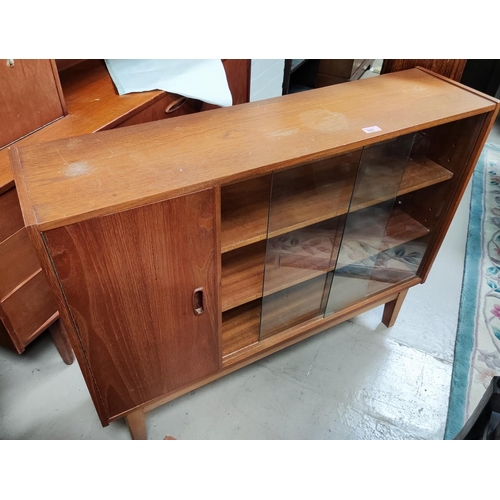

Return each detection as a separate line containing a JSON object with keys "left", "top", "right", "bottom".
{"left": 11, "top": 69, "right": 496, "bottom": 230}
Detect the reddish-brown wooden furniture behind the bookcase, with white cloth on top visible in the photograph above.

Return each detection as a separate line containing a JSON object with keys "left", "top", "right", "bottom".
{"left": 0, "top": 59, "right": 250, "bottom": 362}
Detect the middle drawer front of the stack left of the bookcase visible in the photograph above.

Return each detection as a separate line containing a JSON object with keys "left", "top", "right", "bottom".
{"left": 0, "top": 227, "right": 40, "bottom": 300}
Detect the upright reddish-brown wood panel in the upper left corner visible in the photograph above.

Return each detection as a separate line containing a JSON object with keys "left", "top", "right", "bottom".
{"left": 0, "top": 59, "right": 64, "bottom": 148}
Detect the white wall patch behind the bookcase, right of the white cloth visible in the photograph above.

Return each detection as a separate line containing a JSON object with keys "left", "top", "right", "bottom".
{"left": 250, "top": 59, "right": 285, "bottom": 102}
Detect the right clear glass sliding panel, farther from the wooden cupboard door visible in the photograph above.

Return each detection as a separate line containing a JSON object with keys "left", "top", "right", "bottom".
{"left": 325, "top": 134, "right": 416, "bottom": 315}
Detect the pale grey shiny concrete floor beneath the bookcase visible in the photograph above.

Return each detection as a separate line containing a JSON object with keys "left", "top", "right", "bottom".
{"left": 0, "top": 79, "right": 500, "bottom": 440}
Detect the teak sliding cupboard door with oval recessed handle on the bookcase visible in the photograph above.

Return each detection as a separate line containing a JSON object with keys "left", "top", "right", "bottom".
{"left": 44, "top": 189, "right": 220, "bottom": 418}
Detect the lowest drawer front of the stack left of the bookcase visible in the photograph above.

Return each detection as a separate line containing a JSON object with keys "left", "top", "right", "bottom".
{"left": 1, "top": 270, "right": 57, "bottom": 345}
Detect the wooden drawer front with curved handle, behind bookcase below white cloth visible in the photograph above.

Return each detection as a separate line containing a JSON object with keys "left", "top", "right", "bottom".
{"left": 115, "top": 93, "right": 200, "bottom": 128}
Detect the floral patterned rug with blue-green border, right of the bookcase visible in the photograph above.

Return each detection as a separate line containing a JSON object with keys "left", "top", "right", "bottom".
{"left": 444, "top": 143, "right": 500, "bottom": 439}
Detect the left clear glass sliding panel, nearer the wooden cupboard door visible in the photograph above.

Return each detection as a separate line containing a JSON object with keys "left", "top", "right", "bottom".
{"left": 260, "top": 151, "right": 361, "bottom": 339}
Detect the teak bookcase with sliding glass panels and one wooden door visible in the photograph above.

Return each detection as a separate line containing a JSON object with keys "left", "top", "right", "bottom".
{"left": 11, "top": 68, "right": 499, "bottom": 438}
